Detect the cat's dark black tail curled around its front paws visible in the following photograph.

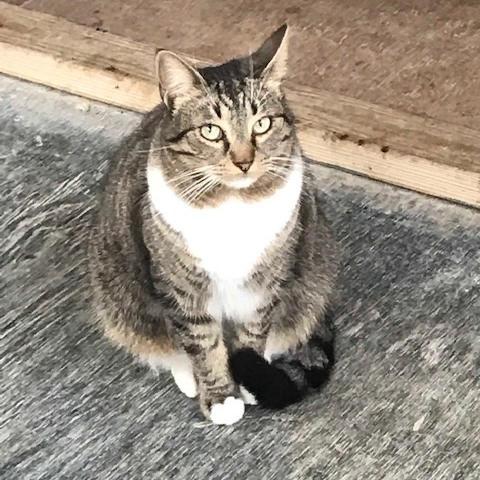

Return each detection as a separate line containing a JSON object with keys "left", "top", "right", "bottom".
{"left": 230, "top": 337, "right": 335, "bottom": 409}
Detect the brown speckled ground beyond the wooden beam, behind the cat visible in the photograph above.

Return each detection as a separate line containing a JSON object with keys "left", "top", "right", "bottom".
{"left": 7, "top": 0, "right": 480, "bottom": 130}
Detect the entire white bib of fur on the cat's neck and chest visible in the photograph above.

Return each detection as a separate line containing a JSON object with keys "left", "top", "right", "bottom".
{"left": 147, "top": 163, "right": 302, "bottom": 321}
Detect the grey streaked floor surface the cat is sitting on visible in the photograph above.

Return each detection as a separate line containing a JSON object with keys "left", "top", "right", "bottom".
{"left": 0, "top": 77, "right": 480, "bottom": 480}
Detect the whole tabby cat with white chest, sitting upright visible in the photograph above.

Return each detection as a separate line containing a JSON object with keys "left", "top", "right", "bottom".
{"left": 89, "top": 25, "right": 338, "bottom": 425}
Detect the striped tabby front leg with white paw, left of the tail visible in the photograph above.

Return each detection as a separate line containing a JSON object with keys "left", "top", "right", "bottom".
{"left": 174, "top": 316, "right": 245, "bottom": 425}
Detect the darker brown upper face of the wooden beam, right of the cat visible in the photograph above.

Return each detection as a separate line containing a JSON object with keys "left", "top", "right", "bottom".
{"left": 290, "top": 87, "right": 480, "bottom": 173}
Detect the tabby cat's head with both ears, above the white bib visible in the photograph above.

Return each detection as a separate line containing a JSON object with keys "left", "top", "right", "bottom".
{"left": 151, "top": 25, "right": 300, "bottom": 204}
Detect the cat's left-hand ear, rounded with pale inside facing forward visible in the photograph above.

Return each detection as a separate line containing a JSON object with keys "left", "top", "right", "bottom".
{"left": 155, "top": 50, "right": 204, "bottom": 109}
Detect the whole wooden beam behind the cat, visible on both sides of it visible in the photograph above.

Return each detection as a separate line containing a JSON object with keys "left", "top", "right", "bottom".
{"left": 0, "top": 2, "right": 480, "bottom": 207}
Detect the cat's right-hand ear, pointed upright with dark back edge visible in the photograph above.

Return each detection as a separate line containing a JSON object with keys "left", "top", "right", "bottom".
{"left": 251, "top": 24, "right": 288, "bottom": 88}
